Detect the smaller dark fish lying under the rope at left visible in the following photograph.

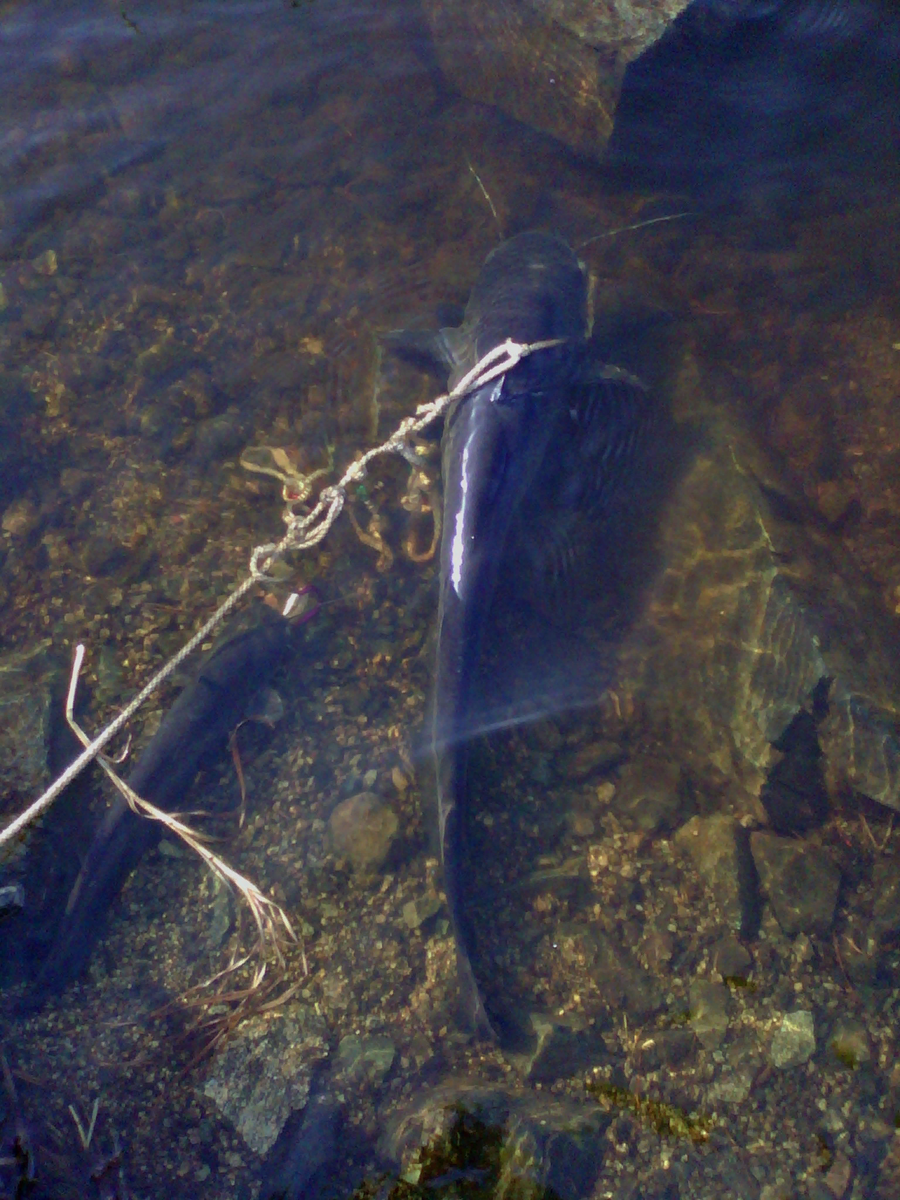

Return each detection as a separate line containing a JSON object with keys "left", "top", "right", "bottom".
{"left": 31, "top": 605, "right": 292, "bottom": 1003}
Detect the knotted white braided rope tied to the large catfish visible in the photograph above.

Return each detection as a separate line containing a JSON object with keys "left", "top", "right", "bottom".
{"left": 0, "top": 337, "right": 564, "bottom": 846}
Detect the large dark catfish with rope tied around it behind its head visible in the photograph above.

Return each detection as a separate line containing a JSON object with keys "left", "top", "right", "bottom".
{"left": 433, "top": 234, "right": 587, "bottom": 1036}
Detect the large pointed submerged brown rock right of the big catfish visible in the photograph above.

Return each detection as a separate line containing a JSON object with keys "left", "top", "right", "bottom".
{"left": 619, "top": 393, "right": 900, "bottom": 822}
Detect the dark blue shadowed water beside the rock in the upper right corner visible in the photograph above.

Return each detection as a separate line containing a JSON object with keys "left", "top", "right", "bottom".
{"left": 608, "top": 0, "right": 900, "bottom": 212}
